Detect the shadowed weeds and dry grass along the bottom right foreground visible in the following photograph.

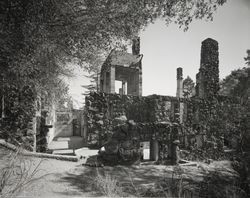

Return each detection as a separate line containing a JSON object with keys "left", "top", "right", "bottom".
{"left": 93, "top": 166, "right": 247, "bottom": 198}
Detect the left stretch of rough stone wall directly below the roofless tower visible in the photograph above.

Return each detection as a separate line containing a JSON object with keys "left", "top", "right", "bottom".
{"left": 85, "top": 92, "right": 182, "bottom": 145}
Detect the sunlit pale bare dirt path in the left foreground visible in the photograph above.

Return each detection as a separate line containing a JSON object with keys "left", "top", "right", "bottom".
{"left": 20, "top": 159, "right": 94, "bottom": 197}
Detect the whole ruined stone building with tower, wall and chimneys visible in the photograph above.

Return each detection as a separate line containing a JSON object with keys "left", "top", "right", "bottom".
{"left": 85, "top": 38, "right": 225, "bottom": 160}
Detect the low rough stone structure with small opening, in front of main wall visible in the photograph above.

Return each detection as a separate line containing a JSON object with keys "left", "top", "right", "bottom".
{"left": 99, "top": 121, "right": 179, "bottom": 165}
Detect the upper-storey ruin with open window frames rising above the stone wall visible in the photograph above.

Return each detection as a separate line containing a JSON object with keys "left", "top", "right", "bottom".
{"left": 100, "top": 38, "right": 142, "bottom": 96}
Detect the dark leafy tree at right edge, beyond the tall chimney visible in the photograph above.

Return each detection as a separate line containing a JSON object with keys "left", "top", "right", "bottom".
{"left": 220, "top": 50, "right": 250, "bottom": 150}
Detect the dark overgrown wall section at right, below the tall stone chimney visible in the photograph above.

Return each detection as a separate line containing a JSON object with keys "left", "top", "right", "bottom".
{"left": 184, "top": 96, "right": 250, "bottom": 159}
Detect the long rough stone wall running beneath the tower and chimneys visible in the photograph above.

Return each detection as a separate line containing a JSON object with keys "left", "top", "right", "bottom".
{"left": 85, "top": 92, "right": 243, "bottom": 157}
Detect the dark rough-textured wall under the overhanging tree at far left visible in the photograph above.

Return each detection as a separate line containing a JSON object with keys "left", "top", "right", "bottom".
{"left": 0, "top": 85, "right": 35, "bottom": 150}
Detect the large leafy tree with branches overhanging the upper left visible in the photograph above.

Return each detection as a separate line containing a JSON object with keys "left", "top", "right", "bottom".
{"left": 0, "top": 0, "right": 226, "bottom": 145}
